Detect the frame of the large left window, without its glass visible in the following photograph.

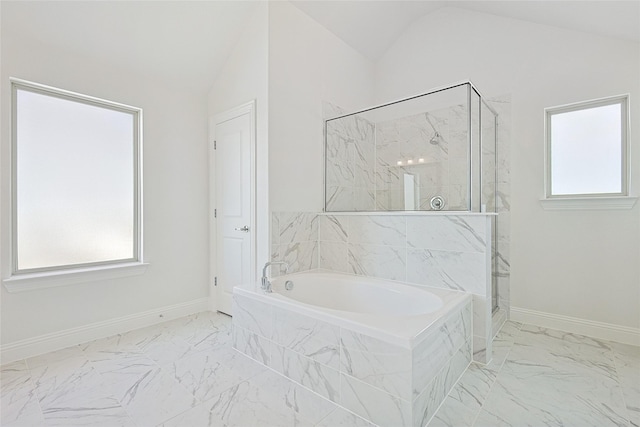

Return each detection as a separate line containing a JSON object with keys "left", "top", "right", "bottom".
{"left": 9, "top": 78, "right": 146, "bottom": 280}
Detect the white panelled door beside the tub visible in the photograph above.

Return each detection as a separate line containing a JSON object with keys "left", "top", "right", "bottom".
{"left": 213, "top": 103, "right": 255, "bottom": 315}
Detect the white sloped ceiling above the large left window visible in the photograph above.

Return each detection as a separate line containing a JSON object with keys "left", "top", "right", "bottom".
{"left": 0, "top": 0, "right": 256, "bottom": 90}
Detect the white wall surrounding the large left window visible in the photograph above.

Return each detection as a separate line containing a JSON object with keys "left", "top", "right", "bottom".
{"left": 0, "top": 36, "right": 208, "bottom": 346}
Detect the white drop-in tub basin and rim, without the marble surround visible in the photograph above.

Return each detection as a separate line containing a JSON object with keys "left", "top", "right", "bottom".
{"left": 234, "top": 272, "right": 471, "bottom": 348}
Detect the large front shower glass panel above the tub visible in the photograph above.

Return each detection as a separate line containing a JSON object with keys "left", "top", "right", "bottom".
{"left": 325, "top": 83, "right": 470, "bottom": 212}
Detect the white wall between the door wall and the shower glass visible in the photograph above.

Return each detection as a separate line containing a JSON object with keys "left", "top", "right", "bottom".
{"left": 269, "top": 2, "right": 373, "bottom": 212}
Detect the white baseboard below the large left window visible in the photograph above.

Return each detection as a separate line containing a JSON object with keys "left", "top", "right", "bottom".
{"left": 0, "top": 298, "right": 209, "bottom": 364}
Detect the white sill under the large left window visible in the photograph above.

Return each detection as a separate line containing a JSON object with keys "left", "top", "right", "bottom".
{"left": 2, "top": 262, "right": 149, "bottom": 293}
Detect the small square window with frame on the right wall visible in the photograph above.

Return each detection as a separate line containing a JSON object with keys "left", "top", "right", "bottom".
{"left": 545, "top": 96, "right": 629, "bottom": 199}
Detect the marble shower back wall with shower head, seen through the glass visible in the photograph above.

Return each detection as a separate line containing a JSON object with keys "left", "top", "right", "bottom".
{"left": 375, "top": 105, "right": 469, "bottom": 211}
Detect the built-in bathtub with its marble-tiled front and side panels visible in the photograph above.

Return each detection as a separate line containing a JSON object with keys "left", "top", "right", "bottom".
{"left": 233, "top": 271, "right": 473, "bottom": 427}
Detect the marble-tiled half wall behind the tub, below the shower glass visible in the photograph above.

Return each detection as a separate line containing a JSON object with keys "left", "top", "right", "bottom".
{"left": 272, "top": 212, "right": 495, "bottom": 363}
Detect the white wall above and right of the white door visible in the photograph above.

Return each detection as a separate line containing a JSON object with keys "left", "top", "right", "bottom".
{"left": 209, "top": 2, "right": 269, "bottom": 307}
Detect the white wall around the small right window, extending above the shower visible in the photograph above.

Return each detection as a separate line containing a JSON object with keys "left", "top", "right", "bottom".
{"left": 376, "top": 8, "right": 640, "bottom": 328}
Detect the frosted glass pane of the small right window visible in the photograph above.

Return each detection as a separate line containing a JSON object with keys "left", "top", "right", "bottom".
{"left": 550, "top": 103, "right": 623, "bottom": 195}
